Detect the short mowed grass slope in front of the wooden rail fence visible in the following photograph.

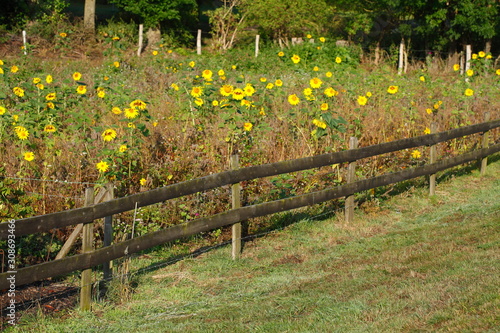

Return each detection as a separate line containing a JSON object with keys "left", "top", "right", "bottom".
{"left": 8, "top": 156, "right": 500, "bottom": 332}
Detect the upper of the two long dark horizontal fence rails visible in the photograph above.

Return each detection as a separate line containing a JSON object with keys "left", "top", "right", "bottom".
{"left": 0, "top": 119, "right": 500, "bottom": 240}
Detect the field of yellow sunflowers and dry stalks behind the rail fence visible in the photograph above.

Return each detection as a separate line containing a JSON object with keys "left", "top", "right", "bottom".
{"left": 0, "top": 33, "right": 500, "bottom": 255}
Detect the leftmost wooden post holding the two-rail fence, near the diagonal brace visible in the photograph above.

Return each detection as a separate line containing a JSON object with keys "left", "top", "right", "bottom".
{"left": 80, "top": 187, "right": 94, "bottom": 311}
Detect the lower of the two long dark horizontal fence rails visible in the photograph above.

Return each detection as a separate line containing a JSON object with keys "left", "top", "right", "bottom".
{"left": 0, "top": 144, "right": 500, "bottom": 290}
